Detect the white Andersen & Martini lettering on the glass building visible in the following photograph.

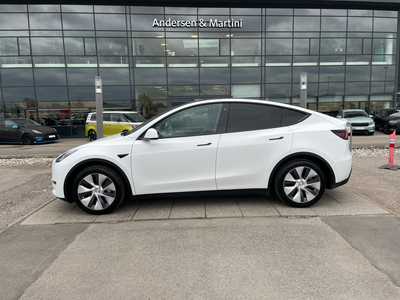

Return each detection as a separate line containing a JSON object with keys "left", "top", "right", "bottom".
{"left": 153, "top": 18, "right": 243, "bottom": 28}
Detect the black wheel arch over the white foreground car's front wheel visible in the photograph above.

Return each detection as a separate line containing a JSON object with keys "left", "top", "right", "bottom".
{"left": 63, "top": 158, "right": 133, "bottom": 203}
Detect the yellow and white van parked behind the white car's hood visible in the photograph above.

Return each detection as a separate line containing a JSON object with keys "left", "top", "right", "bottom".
{"left": 85, "top": 111, "right": 146, "bottom": 141}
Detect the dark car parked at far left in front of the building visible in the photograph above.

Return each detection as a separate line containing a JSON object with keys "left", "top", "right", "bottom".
{"left": 0, "top": 119, "right": 59, "bottom": 145}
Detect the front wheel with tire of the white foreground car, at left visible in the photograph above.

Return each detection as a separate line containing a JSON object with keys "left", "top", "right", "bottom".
{"left": 72, "top": 166, "right": 126, "bottom": 215}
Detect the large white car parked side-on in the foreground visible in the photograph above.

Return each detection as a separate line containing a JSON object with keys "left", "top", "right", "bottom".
{"left": 52, "top": 99, "right": 352, "bottom": 214}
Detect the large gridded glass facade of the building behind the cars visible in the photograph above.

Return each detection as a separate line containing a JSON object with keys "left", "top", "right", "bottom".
{"left": 0, "top": 5, "right": 399, "bottom": 136}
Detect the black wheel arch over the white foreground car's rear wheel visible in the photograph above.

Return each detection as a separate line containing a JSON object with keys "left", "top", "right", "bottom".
{"left": 268, "top": 152, "right": 336, "bottom": 189}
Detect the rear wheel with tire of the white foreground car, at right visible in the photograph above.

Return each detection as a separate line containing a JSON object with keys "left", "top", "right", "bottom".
{"left": 275, "top": 159, "right": 326, "bottom": 207}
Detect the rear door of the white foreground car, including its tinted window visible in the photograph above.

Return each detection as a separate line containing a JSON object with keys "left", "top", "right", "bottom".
{"left": 216, "top": 103, "right": 293, "bottom": 190}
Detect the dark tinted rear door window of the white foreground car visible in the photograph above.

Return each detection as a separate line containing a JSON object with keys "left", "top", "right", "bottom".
{"left": 227, "top": 103, "right": 282, "bottom": 132}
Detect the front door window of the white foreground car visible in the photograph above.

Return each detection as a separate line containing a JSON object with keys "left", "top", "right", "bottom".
{"left": 155, "top": 103, "right": 222, "bottom": 138}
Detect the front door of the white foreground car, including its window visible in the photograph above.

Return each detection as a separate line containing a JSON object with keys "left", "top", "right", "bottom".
{"left": 132, "top": 103, "right": 222, "bottom": 194}
